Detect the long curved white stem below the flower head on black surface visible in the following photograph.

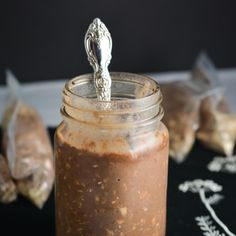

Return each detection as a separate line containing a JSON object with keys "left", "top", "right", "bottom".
{"left": 199, "top": 189, "right": 236, "bottom": 236}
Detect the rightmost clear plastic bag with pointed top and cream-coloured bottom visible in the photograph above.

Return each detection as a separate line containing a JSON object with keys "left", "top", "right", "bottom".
{"left": 193, "top": 54, "right": 236, "bottom": 156}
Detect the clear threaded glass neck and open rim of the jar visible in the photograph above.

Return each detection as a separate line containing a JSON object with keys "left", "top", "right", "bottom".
{"left": 61, "top": 72, "right": 164, "bottom": 128}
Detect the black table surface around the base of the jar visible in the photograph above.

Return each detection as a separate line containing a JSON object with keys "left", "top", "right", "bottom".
{"left": 0, "top": 129, "right": 236, "bottom": 236}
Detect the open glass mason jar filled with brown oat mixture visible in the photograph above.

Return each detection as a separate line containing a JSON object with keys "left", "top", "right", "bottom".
{"left": 55, "top": 73, "right": 169, "bottom": 236}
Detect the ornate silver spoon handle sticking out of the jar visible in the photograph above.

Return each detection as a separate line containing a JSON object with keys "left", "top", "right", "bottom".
{"left": 84, "top": 18, "right": 112, "bottom": 101}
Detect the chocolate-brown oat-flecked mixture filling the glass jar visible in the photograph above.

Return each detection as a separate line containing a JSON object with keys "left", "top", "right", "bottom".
{"left": 55, "top": 130, "right": 168, "bottom": 236}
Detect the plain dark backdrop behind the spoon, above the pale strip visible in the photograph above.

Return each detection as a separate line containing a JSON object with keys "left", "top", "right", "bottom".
{"left": 0, "top": 0, "right": 236, "bottom": 83}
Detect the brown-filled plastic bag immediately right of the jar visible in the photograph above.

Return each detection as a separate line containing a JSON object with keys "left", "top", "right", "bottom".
{"left": 161, "top": 81, "right": 200, "bottom": 163}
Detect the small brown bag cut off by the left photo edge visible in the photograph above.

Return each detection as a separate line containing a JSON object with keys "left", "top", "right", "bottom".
{"left": 0, "top": 154, "right": 17, "bottom": 203}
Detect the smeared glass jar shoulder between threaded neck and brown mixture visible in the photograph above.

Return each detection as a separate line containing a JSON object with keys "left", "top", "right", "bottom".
{"left": 54, "top": 122, "right": 169, "bottom": 158}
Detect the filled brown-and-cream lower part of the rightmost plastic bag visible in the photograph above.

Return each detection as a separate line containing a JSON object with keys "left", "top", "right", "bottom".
{"left": 197, "top": 94, "right": 236, "bottom": 156}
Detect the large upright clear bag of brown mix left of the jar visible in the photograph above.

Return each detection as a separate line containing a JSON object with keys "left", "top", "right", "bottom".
{"left": 3, "top": 71, "right": 54, "bottom": 208}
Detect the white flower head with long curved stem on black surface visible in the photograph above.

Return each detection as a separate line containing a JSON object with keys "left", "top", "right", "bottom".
{"left": 179, "top": 179, "right": 236, "bottom": 236}
